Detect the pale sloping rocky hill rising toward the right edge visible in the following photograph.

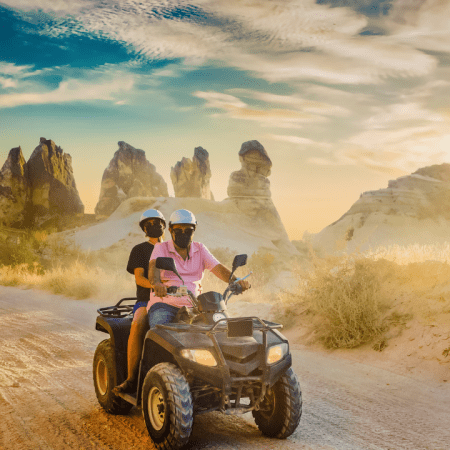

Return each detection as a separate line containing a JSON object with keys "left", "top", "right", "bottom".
{"left": 313, "top": 164, "right": 450, "bottom": 252}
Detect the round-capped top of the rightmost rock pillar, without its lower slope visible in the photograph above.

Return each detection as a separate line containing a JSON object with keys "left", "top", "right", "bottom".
{"left": 227, "top": 141, "right": 272, "bottom": 198}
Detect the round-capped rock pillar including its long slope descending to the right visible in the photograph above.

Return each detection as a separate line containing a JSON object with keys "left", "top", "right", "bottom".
{"left": 227, "top": 141, "right": 297, "bottom": 254}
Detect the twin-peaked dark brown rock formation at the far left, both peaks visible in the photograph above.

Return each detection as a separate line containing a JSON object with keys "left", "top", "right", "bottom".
{"left": 0, "top": 138, "right": 84, "bottom": 226}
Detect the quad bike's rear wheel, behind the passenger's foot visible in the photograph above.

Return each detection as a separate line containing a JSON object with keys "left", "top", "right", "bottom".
{"left": 93, "top": 339, "right": 133, "bottom": 414}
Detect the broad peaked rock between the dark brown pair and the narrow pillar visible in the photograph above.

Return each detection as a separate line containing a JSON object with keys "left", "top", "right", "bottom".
{"left": 95, "top": 141, "right": 169, "bottom": 216}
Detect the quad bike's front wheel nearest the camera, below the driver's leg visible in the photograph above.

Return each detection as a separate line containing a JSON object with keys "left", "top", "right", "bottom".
{"left": 142, "top": 363, "right": 194, "bottom": 450}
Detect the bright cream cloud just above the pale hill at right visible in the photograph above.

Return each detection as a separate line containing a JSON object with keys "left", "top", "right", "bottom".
{"left": 302, "top": 96, "right": 450, "bottom": 176}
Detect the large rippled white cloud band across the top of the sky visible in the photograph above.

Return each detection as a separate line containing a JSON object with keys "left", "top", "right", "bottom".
{"left": 7, "top": 0, "right": 445, "bottom": 85}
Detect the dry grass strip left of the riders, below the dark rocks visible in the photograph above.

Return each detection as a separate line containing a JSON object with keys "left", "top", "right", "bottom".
{"left": 0, "top": 231, "right": 135, "bottom": 302}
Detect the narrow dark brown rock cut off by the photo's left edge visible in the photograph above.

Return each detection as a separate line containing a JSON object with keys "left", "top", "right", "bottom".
{"left": 0, "top": 147, "right": 29, "bottom": 227}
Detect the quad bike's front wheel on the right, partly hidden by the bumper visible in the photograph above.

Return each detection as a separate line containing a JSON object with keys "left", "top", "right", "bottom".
{"left": 252, "top": 368, "right": 302, "bottom": 439}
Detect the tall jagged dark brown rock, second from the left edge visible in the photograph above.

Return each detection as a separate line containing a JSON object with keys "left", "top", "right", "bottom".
{"left": 27, "top": 138, "right": 84, "bottom": 224}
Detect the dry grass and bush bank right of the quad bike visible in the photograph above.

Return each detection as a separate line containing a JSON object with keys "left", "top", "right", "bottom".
{"left": 278, "top": 244, "right": 450, "bottom": 351}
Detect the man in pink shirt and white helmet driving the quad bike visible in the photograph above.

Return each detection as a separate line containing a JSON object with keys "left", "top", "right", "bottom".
{"left": 147, "top": 209, "right": 250, "bottom": 328}
